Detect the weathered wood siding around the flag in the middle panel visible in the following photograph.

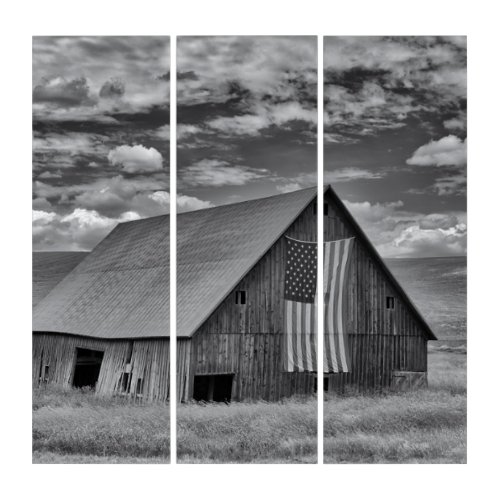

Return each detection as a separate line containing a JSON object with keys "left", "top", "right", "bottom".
{"left": 182, "top": 203, "right": 316, "bottom": 401}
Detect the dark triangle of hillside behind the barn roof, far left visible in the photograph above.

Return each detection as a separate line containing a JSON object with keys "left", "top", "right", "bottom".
{"left": 32, "top": 252, "right": 88, "bottom": 307}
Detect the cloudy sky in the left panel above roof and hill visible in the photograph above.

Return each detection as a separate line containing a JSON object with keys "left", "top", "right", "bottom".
{"left": 32, "top": 37, "right": 170, "bottom": 250}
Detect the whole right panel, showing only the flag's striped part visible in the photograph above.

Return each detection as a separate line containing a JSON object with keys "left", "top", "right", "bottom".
{"left": 323, "top": 36, "right": 467, "bottom": 464}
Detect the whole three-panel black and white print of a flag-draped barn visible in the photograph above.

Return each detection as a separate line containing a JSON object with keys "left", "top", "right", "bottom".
{"left": 27, "top": 26, "right": 468, "bottom": 472}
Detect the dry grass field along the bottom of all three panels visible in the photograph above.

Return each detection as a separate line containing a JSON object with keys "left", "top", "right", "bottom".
{"left": 33, "top": 347, "right": 467, "bottom": 463}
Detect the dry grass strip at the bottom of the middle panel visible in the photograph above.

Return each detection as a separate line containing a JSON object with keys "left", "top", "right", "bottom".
{"left": 177, "top": 398, "right": 317, "bottom": 463}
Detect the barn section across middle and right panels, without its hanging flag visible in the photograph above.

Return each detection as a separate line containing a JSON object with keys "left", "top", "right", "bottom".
{"left": 177, "top": 187, "right": 435, "bottom": 401}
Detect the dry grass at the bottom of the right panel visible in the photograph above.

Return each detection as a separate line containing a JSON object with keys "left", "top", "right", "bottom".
{"left": 324, "top": 350, "right": 467, "bottom": 463}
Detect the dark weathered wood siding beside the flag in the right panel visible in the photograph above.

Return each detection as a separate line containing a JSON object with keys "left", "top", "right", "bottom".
{"left": 324, "top": 191, "right": 427, "bottom": 391}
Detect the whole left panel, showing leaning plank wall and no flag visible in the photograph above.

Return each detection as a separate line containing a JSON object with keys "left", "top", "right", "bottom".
{"left": 32, "top": 36, "right": 170, "bottom": 463}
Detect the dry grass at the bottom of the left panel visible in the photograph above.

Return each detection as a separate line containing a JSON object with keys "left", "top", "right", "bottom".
{"left": 33, "top": 385, "right": 170, "bottom": 463}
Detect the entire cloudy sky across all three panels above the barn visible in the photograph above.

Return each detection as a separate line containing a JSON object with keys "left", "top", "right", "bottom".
{"left": 33, "top": 37, "right": 467, "bottom": 257}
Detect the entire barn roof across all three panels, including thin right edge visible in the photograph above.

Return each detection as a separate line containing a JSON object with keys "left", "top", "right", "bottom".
{"left": 33, "top": 188, "right": 434, "bottom": 338}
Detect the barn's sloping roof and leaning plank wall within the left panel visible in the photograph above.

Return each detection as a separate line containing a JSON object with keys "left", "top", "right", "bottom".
{"left": 32, "top": 216, "right": 170, "bottom": 401}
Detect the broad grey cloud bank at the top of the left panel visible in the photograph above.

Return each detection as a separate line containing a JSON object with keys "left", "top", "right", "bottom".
{"left": 33, "top": 36, "right": 170, "bottom": 123}
